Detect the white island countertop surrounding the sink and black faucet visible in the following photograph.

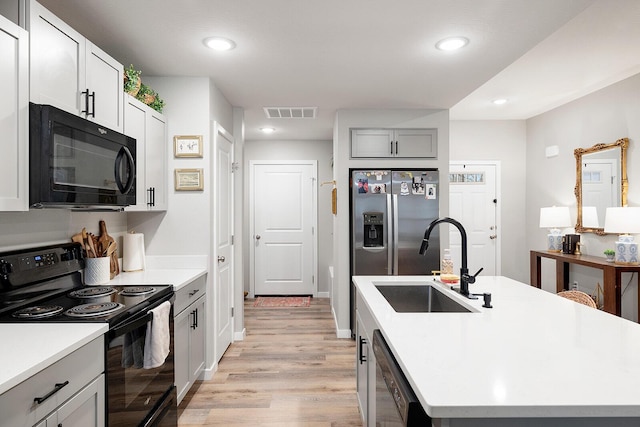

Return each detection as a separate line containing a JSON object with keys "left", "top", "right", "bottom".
{"left": 353, "top": 276, "right": 640, "bottom": 418}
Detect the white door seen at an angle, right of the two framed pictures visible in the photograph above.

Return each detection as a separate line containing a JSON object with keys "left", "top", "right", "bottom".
{"left": 213, "top": 123, "right": 233, "bottom": 361}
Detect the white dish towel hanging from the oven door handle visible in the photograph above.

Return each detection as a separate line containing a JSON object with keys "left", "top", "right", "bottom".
{"left": 143, "top": 301, "right": 171, "bottom": 369}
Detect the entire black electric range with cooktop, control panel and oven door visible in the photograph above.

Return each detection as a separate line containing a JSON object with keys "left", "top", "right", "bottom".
{"left": 0, "top": 243, "right": 178, "bottom": 427}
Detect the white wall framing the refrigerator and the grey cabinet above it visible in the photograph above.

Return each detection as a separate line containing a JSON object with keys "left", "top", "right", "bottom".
{"left": 331, "top": 109, "right": 449, "bottom": 337}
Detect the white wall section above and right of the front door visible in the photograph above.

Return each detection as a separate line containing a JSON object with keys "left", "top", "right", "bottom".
{"left": 449, "top": 120, "right": 529, "bottom": 283}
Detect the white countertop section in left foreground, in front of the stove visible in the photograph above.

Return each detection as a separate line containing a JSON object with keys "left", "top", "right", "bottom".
{"left": 0, "top": 323, "right": 109, "bottom": 394}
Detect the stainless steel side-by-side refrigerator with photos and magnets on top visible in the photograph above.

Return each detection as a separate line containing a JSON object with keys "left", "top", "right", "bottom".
{"left": 351, "top": 169, "right": 440, "bottom": 276}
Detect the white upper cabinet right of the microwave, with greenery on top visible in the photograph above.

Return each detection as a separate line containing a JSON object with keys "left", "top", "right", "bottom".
{"left": 124, "top": 95, "right": 169, "bottom": 211}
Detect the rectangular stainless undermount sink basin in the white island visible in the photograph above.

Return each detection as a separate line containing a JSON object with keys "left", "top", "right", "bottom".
{"left": 375, "top": 284, "right": 472, "bottom": 313}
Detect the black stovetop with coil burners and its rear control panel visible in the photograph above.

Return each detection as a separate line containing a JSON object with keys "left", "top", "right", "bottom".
{"left": 0, "top": 243, "right": 173, "bottom": 325}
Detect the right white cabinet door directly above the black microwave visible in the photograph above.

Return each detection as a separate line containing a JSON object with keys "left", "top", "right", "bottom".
{"left": 83, "top": 40, "right": 124, "bottom": 132}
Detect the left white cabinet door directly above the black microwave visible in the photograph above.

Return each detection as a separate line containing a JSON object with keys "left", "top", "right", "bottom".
{"left": 28, "top": 1, "right": 86, "bottom": 115}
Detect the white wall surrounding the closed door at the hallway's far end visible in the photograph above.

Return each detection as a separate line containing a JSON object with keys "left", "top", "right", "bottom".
{"left": 243, "top": 140, "right": 333, "bottom": 297}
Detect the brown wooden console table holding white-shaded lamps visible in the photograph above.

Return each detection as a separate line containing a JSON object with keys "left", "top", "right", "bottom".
{"left": 530, "top": 251, "right": 640, "bottom": 321}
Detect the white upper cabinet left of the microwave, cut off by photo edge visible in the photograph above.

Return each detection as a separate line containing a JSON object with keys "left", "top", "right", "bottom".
{"left": 0, "top": 12, "right": 29, "bottom": 211}
